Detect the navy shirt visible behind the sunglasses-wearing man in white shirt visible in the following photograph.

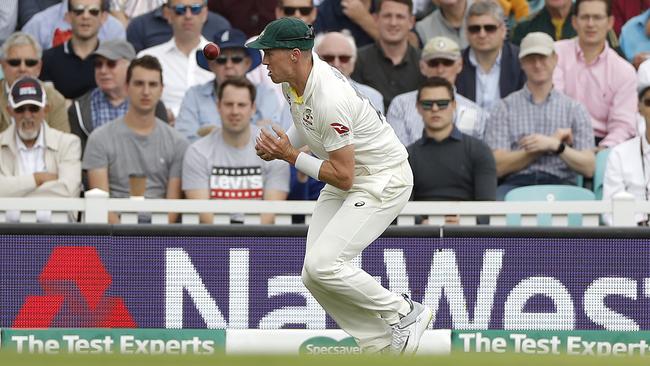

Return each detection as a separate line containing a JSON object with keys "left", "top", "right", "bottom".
{"left": 126, "top": 5, "right": 230, "bottom": 52}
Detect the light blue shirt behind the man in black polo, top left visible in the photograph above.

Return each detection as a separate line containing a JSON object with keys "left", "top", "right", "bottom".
{"left": 22, "top": 0, "right": 126, "bottom": 50}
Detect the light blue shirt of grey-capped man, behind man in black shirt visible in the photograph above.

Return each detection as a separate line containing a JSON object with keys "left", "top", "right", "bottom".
{"left": 386, "top": 90, "right": 488, "bottom": 146}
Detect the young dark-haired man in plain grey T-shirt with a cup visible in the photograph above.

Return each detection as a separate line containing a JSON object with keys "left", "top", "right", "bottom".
{"left": 83, "top": 56, "right": 188, "bottom": 224}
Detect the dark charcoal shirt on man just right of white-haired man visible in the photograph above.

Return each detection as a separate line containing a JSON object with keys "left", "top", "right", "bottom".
{"left": 352, "top": 43, "right": 423, "bottom": 109}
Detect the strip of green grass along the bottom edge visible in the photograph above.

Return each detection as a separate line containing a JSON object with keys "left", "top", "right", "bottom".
{"left": 0, "top": 351, "right": 650, "bottom": 366}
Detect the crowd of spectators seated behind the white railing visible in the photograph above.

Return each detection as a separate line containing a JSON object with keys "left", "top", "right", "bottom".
{"left": 0, "top": 0, "right": 650, "bottom": 224}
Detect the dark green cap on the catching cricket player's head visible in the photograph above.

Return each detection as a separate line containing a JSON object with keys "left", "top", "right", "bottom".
{"left": 246, "top": 18, "right": 314, "bottom": 50}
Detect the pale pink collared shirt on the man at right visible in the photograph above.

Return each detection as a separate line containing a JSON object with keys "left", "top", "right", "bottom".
{"left": 553, "top": 38, "right": 637, "bottom": 147}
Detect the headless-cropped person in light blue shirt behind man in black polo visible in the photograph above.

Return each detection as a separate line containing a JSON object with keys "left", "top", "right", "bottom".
{"left": 22, "top": 0, "right": 126, "bottom": 50}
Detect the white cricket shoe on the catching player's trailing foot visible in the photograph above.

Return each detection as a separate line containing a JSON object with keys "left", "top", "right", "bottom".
{"left": 390, "top": 295, "right": 433, "bottom": 355}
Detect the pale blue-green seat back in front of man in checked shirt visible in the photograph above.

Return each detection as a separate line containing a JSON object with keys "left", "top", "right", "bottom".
{"left": 505, "top": 184, "right": 595, "bottom": 226}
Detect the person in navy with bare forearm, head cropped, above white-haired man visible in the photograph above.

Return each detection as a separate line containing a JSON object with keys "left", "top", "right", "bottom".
{"left": 312, "top": 0, "right": 374, "bottom": 47}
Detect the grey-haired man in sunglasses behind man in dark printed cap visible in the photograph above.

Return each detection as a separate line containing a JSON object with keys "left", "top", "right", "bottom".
{"left": 0, "top": 32, "right": 70, "bottom": 132}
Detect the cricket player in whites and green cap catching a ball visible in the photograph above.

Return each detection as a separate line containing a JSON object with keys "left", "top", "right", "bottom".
{"left": 247, "top": 18, "right": 432, "bottom": 354}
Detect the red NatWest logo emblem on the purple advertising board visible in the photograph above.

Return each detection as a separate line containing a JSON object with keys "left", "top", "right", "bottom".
{"left": 12, "top": 247, "right": 137, "bottom": 328}
